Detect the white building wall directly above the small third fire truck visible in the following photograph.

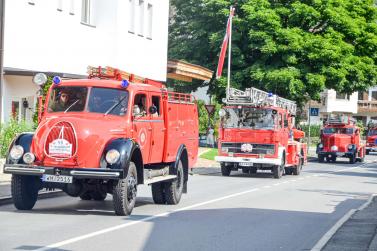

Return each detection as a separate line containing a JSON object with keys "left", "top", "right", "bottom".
{"left": 320, "top": 90, "right": 358, "bottom": 114}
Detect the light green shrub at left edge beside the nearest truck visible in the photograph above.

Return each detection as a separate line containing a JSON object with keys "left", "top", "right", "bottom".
{"left": 0, "top": 119, "right": 33, "bottom": 158}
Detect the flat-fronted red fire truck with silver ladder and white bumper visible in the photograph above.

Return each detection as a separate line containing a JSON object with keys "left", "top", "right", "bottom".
{"left": 216, "top": 88, "right": 307, "bottom": 179}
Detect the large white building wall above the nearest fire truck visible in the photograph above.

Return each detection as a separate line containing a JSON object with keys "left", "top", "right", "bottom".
{"left": 4, "top": 0, "right": 169, "bottom": 81}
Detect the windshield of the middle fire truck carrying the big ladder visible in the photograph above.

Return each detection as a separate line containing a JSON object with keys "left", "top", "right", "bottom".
{"left": 223, "top": 107, "right": 278, "bottom": 130}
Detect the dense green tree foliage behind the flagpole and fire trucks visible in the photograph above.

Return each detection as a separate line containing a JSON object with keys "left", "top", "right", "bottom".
{"left": 169, "top": 0, "right": 377, "bottom": 104}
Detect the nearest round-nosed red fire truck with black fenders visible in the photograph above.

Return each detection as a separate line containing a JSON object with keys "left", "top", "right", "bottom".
{"left": 4, "top": 67, "right": 198, "bottom": 215}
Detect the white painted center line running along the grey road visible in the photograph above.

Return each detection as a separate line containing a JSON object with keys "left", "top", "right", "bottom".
{"left": 35, "top": 165, "right": 363, "bottom": 251}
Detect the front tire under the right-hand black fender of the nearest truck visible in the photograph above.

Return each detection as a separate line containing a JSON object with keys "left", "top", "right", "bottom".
{"left": 113, "top": 162, "right": 137, "bottom": 215}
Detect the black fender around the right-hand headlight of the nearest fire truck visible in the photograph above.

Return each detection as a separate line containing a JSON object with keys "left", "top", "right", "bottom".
{"left": 101, "top": 138, "right": 144, "bottom": 184}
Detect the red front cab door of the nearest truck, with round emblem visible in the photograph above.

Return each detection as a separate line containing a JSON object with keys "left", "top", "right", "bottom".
{"left": 132, "top": 93, "right": 152, "bottom": 164}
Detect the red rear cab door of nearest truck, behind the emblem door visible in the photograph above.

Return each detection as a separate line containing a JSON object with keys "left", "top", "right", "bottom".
{"left": 149, "top": 93, "right": 166, "bottom": 163}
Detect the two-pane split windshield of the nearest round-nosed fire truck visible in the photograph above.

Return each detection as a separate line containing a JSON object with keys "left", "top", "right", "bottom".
{"left": 48, "top": 86, "right": 128, "bottom": 116}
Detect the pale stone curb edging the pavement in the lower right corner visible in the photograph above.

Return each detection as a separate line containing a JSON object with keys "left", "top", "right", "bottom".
{"left": 310, "top": 194, "right": 377, "bottom": 251}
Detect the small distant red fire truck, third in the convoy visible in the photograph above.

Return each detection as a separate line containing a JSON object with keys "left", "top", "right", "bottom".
{"left": 317, "top": 114, "right": 365, "bottom": 164}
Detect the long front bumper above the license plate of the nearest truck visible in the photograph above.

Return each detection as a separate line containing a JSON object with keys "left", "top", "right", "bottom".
{"left": 4, "top": 164, "right": 124, "bottom": 179}
